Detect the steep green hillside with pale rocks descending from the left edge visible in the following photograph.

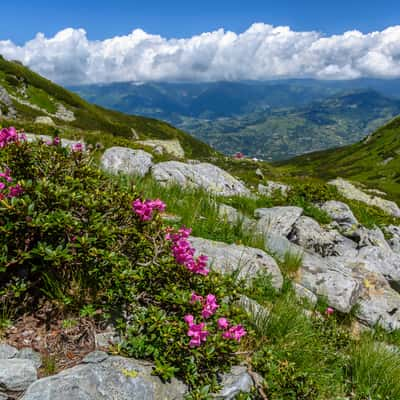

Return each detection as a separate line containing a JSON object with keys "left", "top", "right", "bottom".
{"left": 0, "top": 56, "right": 215, "bottom": 158}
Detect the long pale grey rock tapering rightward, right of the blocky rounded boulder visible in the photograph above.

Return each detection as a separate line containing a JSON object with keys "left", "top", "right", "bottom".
{"left": 152, "top": 161, "right": 250, "bottom": 196}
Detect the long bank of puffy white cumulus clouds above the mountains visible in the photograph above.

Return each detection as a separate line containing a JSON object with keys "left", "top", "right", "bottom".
{"left": 0, "top": 23, "right": 400, "bottom": 84}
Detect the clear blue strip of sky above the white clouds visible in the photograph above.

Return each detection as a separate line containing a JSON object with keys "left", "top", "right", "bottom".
{"left": 0, "top": 0, "right": 400, "bottom": 44}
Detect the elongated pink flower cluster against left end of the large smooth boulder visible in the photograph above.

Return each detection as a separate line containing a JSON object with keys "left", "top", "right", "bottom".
{"left": 166, "top": 227, "right": 209, "bottom": 275}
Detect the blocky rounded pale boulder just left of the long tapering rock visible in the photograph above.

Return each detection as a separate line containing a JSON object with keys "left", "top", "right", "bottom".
{"left": 100, "top": 147, "right": 153, "bottom": 176}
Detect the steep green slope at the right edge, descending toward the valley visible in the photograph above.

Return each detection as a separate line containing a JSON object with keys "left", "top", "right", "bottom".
{"left": 276, "top": 117, "right": 400, "bottom": 201}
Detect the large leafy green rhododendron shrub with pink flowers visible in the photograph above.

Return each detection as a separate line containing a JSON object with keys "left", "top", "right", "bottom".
{"left": 0, "top": 129, "right": 247, "bottom": 388}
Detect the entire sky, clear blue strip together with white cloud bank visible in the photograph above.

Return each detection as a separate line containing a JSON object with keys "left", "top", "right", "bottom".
{"left": 0, "top": 0, "right": 400, "bottom": 84}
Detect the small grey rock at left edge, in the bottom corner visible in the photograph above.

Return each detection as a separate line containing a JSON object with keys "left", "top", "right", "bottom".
{"left": 0, "top": 359, "right": 37, "bottom": 392}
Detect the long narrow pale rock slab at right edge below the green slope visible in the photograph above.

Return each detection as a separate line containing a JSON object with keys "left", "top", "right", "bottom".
{"left": 328, "top": 178, "right": 400, "bottom": 217}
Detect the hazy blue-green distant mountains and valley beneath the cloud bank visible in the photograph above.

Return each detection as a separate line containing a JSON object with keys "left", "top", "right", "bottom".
{"left": 72, "top": 79, "right": 400, "bottom": 160}
